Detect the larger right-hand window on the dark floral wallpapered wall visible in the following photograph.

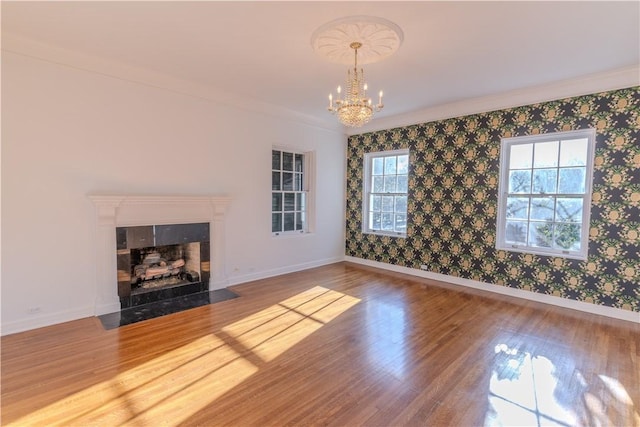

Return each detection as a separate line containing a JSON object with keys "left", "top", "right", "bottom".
{"left": 496, "top": 129, "right": 595, "bottom": 259}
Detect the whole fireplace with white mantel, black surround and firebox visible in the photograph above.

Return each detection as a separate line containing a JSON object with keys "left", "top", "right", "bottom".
{"left": 89, "top": 194, "right": 231, "bottom": 315}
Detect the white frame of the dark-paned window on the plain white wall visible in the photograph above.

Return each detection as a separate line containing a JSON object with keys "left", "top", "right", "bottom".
{"left": 270, "top": 146, "right": 315, "bottom": 237}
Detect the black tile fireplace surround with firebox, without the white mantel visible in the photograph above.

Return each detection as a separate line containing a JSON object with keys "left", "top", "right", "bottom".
{"left": 116, "top": 223, "right": 211, "bottom": 309}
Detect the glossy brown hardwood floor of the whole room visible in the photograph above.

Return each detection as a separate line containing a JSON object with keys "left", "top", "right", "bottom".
{"left": 2, "top": 263, "right": 640, "bottom": 426}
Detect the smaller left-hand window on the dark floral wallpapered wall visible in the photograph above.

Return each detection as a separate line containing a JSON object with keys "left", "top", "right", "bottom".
{"left": 362, "top": 150, "right": 409, "bottom": 237}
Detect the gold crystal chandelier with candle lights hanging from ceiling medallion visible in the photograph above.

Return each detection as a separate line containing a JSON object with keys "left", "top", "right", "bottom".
{"left": 327, "top": 42, "right": 384, "bottom": 127}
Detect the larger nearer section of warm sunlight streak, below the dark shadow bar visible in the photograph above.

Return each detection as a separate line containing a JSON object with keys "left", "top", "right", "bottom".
{"left": 8, "top": 335, "right": 258, "bottom": 426}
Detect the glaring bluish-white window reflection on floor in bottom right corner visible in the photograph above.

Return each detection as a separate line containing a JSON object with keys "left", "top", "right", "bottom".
{"left": 485, "top": 344, "right": 640, "bottom": 426}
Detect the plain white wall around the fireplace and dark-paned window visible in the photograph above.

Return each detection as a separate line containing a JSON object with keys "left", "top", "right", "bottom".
{"left": 1, "top": 52, "right": 346, "bottom": 334}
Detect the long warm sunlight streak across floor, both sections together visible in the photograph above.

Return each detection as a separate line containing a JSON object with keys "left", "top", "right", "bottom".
{"left": 8, "top": 286, "right": 360, "bottom": 426}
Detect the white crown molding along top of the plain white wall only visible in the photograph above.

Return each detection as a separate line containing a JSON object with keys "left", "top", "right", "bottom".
{"left": 2, "top": 33, "right": 344, "bottom": 134}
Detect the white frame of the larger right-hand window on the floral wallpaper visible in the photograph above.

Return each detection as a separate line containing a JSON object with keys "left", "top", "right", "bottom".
{"left": 496, "top": 129, "right": 596, "bottom": 260}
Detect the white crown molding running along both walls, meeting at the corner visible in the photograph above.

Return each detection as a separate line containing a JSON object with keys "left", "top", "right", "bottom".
{"left": 2, "top": 33, "right": 640, "bottom": 136}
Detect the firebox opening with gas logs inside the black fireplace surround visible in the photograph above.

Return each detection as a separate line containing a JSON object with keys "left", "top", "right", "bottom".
{"left": 131, "top": 242, "right": 201, "bottom": 295}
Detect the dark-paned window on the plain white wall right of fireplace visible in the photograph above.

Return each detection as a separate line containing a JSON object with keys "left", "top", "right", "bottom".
{"left": 271, "top": 149, "right": 311, "bottom": 235}
